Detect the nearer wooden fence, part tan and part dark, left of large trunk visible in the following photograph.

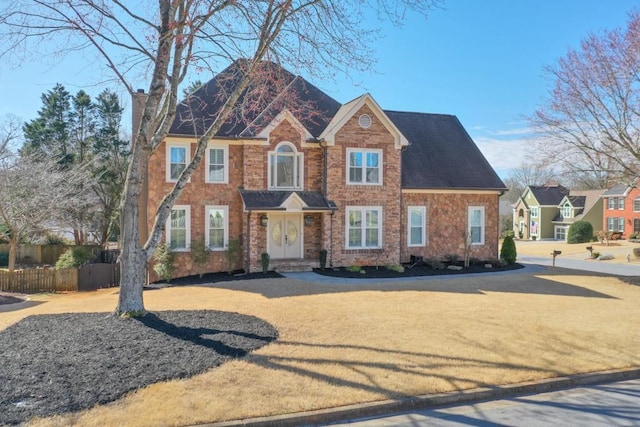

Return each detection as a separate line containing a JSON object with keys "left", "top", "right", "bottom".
{"left": 0, "top": 264, "right": 120, "bottom": 293}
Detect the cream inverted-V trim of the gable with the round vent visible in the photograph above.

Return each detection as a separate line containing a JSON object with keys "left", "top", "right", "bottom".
{"left": 320, "top": 93, "right": 409, "bottom": 149}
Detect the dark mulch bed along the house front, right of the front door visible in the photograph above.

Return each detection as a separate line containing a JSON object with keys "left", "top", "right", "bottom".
{"left": 313, "top": 263, "right": 524, "bottom": 279}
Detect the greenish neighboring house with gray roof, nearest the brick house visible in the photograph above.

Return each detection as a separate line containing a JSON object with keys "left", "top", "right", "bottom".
{"left": 513, "top": 185, "right": 569, "bottom": 239}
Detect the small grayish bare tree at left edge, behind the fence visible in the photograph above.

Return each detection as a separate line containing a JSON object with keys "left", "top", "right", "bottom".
{"left": 0, "top": 154, "right": 92, "bottom": 271}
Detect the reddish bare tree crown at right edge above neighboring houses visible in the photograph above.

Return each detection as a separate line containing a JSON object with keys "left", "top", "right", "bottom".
{"left": 530, "top": 13, "right": 640, "bottom": 187}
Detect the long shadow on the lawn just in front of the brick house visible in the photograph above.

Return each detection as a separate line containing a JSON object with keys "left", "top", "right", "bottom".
{"left": 190, "top": 266, "right": 618, "bottom": 298}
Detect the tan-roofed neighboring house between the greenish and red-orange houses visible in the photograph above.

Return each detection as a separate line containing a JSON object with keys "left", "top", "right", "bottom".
{"left": 552, "top": 190, "right": 605, "bottom": 240}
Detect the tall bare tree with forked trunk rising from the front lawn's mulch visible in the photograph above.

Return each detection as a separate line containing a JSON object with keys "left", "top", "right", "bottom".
{"left": 0, "top": 0, "right": 441, "bottom": 315}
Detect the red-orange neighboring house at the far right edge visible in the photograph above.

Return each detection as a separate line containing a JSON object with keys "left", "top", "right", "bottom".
{"left": 602, "top": 179, "right": 640, "bottom": 239}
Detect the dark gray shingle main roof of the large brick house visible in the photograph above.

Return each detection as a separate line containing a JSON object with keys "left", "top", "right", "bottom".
{"left": 169, "top": 61, "right": 507, "bottom": 191}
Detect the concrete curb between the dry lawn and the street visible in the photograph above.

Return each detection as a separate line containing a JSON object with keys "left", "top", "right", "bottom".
{"left": 200, "top": 367, "right": 640, "bottom": 427}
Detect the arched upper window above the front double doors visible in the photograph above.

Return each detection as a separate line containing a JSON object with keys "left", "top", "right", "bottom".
{"left": 268, "top": 142, "right": 304, "bottom": 190}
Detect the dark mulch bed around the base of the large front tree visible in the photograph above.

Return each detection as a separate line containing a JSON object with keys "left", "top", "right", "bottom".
{"left": 0, "top": 310, "right": 278, "bottom": 425}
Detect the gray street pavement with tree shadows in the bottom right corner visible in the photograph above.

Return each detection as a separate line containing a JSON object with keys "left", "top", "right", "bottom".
{"left": 331, "top": 380, "right": 640, "bottom": 427}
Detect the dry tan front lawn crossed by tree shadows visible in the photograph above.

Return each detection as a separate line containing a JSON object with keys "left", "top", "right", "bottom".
{"left": 5, "top": 268, "right": 640, "bottom": 426}
